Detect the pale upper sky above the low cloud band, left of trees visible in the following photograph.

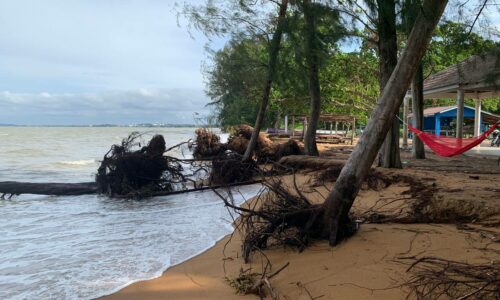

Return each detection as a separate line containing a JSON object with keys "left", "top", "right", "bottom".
{"left": 0, "top": 0, "right": 217, "bottom": 92}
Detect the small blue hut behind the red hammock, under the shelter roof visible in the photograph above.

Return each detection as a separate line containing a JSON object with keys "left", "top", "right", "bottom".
{"left": 409, "top": 105, "right": 500, "bottom": 136}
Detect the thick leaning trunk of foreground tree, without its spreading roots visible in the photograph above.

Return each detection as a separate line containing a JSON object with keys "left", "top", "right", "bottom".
{"left": 322, "top": 0, "right": 447, "bottom": 245}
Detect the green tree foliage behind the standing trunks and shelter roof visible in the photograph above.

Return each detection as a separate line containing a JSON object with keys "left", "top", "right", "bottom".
{"left": 199, "top": 0, "right": 500, "bottom": 127}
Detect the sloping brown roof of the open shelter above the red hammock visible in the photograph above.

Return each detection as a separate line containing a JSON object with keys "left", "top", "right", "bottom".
{"left": 424, "top": 52, "right": 500, "bottom": 98}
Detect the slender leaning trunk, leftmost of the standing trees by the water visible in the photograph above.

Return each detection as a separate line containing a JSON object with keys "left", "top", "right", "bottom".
{"left": 243, "top": 0, "right": 288, "bottom": 160}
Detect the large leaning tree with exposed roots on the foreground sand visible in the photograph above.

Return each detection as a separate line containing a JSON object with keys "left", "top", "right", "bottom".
{"left": 221, "top": 0, "right": 447, "bottom": 253}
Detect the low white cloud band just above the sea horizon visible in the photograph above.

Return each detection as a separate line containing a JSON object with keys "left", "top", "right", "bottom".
{"left": 0, "top": 89, "right": 209, "bottom": 125}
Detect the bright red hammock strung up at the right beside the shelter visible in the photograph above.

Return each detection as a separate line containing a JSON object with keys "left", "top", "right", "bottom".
{"left": 408, "top": 121, "right": 500, "bottom": 157}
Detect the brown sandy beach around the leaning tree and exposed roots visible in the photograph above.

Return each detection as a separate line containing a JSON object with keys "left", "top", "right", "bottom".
{"left": 103, "top": 147, "right": 500, "bottom": 299}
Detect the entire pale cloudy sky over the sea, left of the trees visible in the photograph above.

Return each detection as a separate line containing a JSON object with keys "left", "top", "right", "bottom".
{"left": 0, "top": 0, "right": 220, "bottom": 124}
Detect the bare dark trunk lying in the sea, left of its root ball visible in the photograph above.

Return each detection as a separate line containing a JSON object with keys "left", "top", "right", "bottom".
{"left": 0, "top": 181, "right": 97, "bottom": 196}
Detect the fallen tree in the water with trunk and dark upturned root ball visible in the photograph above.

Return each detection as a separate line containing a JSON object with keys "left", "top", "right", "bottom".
{"left": 0, "top": 132, "right": 188, "bottom": 197}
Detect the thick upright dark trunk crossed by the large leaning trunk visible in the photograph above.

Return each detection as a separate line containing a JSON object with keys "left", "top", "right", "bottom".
{"left": 377, "top": 0, "right": 401, "bottom": 168}
